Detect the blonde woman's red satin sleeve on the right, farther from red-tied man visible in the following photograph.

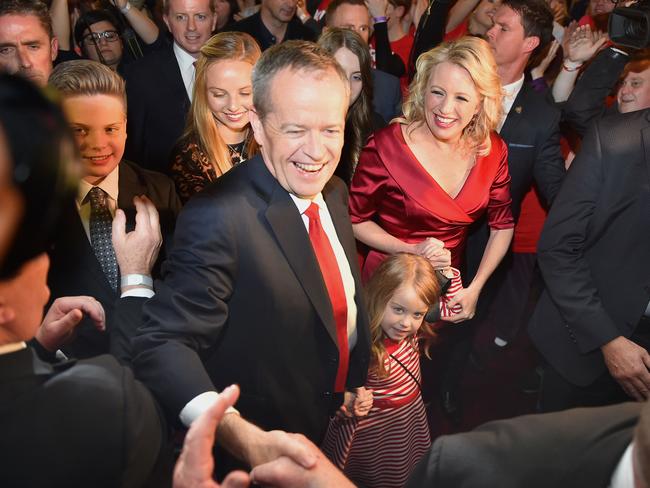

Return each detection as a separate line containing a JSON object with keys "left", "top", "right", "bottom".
{"left": 487, "top": 137, "right": 515, "bottom": 230}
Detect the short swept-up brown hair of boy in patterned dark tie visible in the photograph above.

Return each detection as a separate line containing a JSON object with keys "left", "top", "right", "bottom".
{"left": 49, "top": 59, "right": 126, "bottom": 112}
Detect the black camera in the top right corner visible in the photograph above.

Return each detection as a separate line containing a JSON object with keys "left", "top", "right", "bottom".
{"left": 608, "top": 0, "right": 650, "bottom": 49}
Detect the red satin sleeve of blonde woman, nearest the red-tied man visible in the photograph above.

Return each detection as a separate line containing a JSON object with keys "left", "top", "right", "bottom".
{"left": 349, "top": 138, "right": 388, "bottom": 224}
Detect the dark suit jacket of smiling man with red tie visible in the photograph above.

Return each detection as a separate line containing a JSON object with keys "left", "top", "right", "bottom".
{"left": 133, "top": 155, "right": 369, "bottom": 443}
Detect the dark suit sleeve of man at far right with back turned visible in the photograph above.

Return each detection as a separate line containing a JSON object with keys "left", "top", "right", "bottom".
{"left": 537, "top": 120, "right": 620, "bottom": 353}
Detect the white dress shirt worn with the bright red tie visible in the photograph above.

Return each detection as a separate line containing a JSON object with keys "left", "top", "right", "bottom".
{"left": 179, "top": 193, "right": 357, "bottom": 427}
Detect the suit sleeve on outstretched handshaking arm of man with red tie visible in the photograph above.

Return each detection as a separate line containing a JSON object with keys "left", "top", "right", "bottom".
{"left": 133, "top": 194, "right": 237, "bottom": 420}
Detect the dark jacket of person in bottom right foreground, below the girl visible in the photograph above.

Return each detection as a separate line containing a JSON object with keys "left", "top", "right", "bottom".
{"left": 406, "top": 403, "right": 641, "bottom": 488}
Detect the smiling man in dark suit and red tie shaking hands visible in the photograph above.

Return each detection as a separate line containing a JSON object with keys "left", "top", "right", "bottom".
{"left": 133, "top": 41, "right": 369, "bottom": 474}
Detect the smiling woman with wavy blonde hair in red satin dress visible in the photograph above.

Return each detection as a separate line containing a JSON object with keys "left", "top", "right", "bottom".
{"left": 350, "top": 37, "right": 514, "bottom": 322}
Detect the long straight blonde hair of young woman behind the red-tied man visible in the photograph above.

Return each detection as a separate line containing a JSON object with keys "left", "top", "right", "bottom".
{"left": 182, "top": 32, "right": 262, "bottom": 176}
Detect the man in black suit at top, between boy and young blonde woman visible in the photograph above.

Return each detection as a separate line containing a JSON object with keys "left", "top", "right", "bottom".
{"left": 119, "top": 0, "right": 217, "bottom": 173}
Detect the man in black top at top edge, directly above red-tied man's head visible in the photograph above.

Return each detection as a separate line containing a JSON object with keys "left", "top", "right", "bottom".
{"left": 232, "top": 0, "right": 316, "bottom": 51}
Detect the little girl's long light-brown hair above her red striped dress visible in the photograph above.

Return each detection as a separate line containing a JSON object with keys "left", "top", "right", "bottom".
{"left": 365, "top": 253, "right": 440, "bottom": 378}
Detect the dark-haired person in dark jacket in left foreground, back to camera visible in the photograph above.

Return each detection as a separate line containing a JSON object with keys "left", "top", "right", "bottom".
{"left": 0, "top": 72, "right": 164, "bottom": 488}
